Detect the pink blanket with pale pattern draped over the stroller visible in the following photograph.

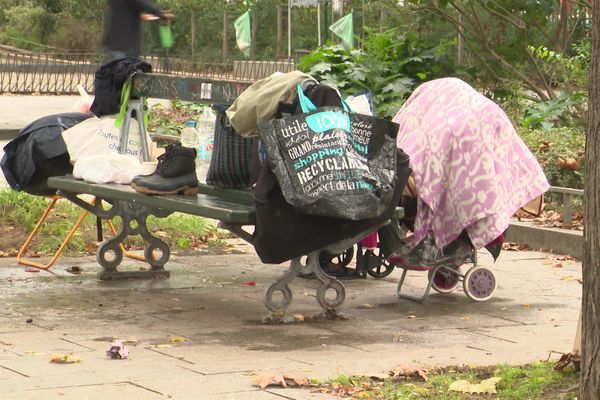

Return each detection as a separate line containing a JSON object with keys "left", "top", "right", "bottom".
{"left": 393, "top": 78, "right": 548, "bottom": 249}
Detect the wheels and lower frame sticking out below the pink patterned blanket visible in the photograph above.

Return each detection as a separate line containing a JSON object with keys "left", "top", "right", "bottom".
{"left": 312, "top": 184, "right": 502, "bottom": 302}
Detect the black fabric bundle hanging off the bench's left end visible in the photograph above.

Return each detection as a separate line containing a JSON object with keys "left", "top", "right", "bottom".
{"left": 0, "top": 113, "right": 91, "bottom": 196}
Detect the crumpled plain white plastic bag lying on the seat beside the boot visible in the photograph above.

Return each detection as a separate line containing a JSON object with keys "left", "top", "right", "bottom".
{"left": 73, "top": 154, "right": 144, "bottom": 185}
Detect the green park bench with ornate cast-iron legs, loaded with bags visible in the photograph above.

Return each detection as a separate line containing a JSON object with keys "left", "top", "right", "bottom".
{"left": 48, "top": 73, "right": 402, "bottom": 312}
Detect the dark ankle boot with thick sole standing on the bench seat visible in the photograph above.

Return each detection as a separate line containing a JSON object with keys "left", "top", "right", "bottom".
{"left": 131, "top": 143, "right": 198, "bottom": 195}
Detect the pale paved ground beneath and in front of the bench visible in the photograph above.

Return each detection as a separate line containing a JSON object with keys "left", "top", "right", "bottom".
{"left": 0, "top": 242, "right": 581, "bottom": 400}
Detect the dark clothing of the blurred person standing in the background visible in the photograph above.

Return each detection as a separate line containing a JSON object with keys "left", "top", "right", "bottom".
{"left": 102, "top": 0, "right": 163, "bottom": 55}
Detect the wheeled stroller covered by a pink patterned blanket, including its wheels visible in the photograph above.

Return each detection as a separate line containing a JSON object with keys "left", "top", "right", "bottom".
{"left": 304, "top": 78, "right": 549, "bottom": 301}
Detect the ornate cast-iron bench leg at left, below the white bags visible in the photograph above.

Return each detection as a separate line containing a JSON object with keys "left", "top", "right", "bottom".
{"left": 59, "top": 191, "right": 171, "bottom": 280}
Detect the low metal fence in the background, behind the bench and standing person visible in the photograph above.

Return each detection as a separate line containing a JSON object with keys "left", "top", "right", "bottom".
{"left": 0, "top": 46, "right": 295, "bottom": 94}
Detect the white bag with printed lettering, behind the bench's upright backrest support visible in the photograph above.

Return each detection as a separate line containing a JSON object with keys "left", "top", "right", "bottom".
{"left": 62, "top": 115, "right": 150, "bottom": 163}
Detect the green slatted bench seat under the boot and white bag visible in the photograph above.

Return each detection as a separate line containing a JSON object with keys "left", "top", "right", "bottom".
{"left": 48, "top": 177, "right": 255, "bottom": 225}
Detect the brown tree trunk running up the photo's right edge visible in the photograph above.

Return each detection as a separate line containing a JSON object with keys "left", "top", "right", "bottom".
{"left": 579, "top": 1, "right": 600, "bottom": 400}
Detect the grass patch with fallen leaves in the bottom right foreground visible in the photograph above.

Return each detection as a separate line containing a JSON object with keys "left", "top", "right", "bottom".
{"left": 317, "top": 362, "right": 579, "bottom": 400}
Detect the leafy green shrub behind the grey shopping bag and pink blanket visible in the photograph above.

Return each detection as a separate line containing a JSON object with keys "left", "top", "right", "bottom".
{"left": 299, "top": 29, "right": 454, "bottom": 117}
